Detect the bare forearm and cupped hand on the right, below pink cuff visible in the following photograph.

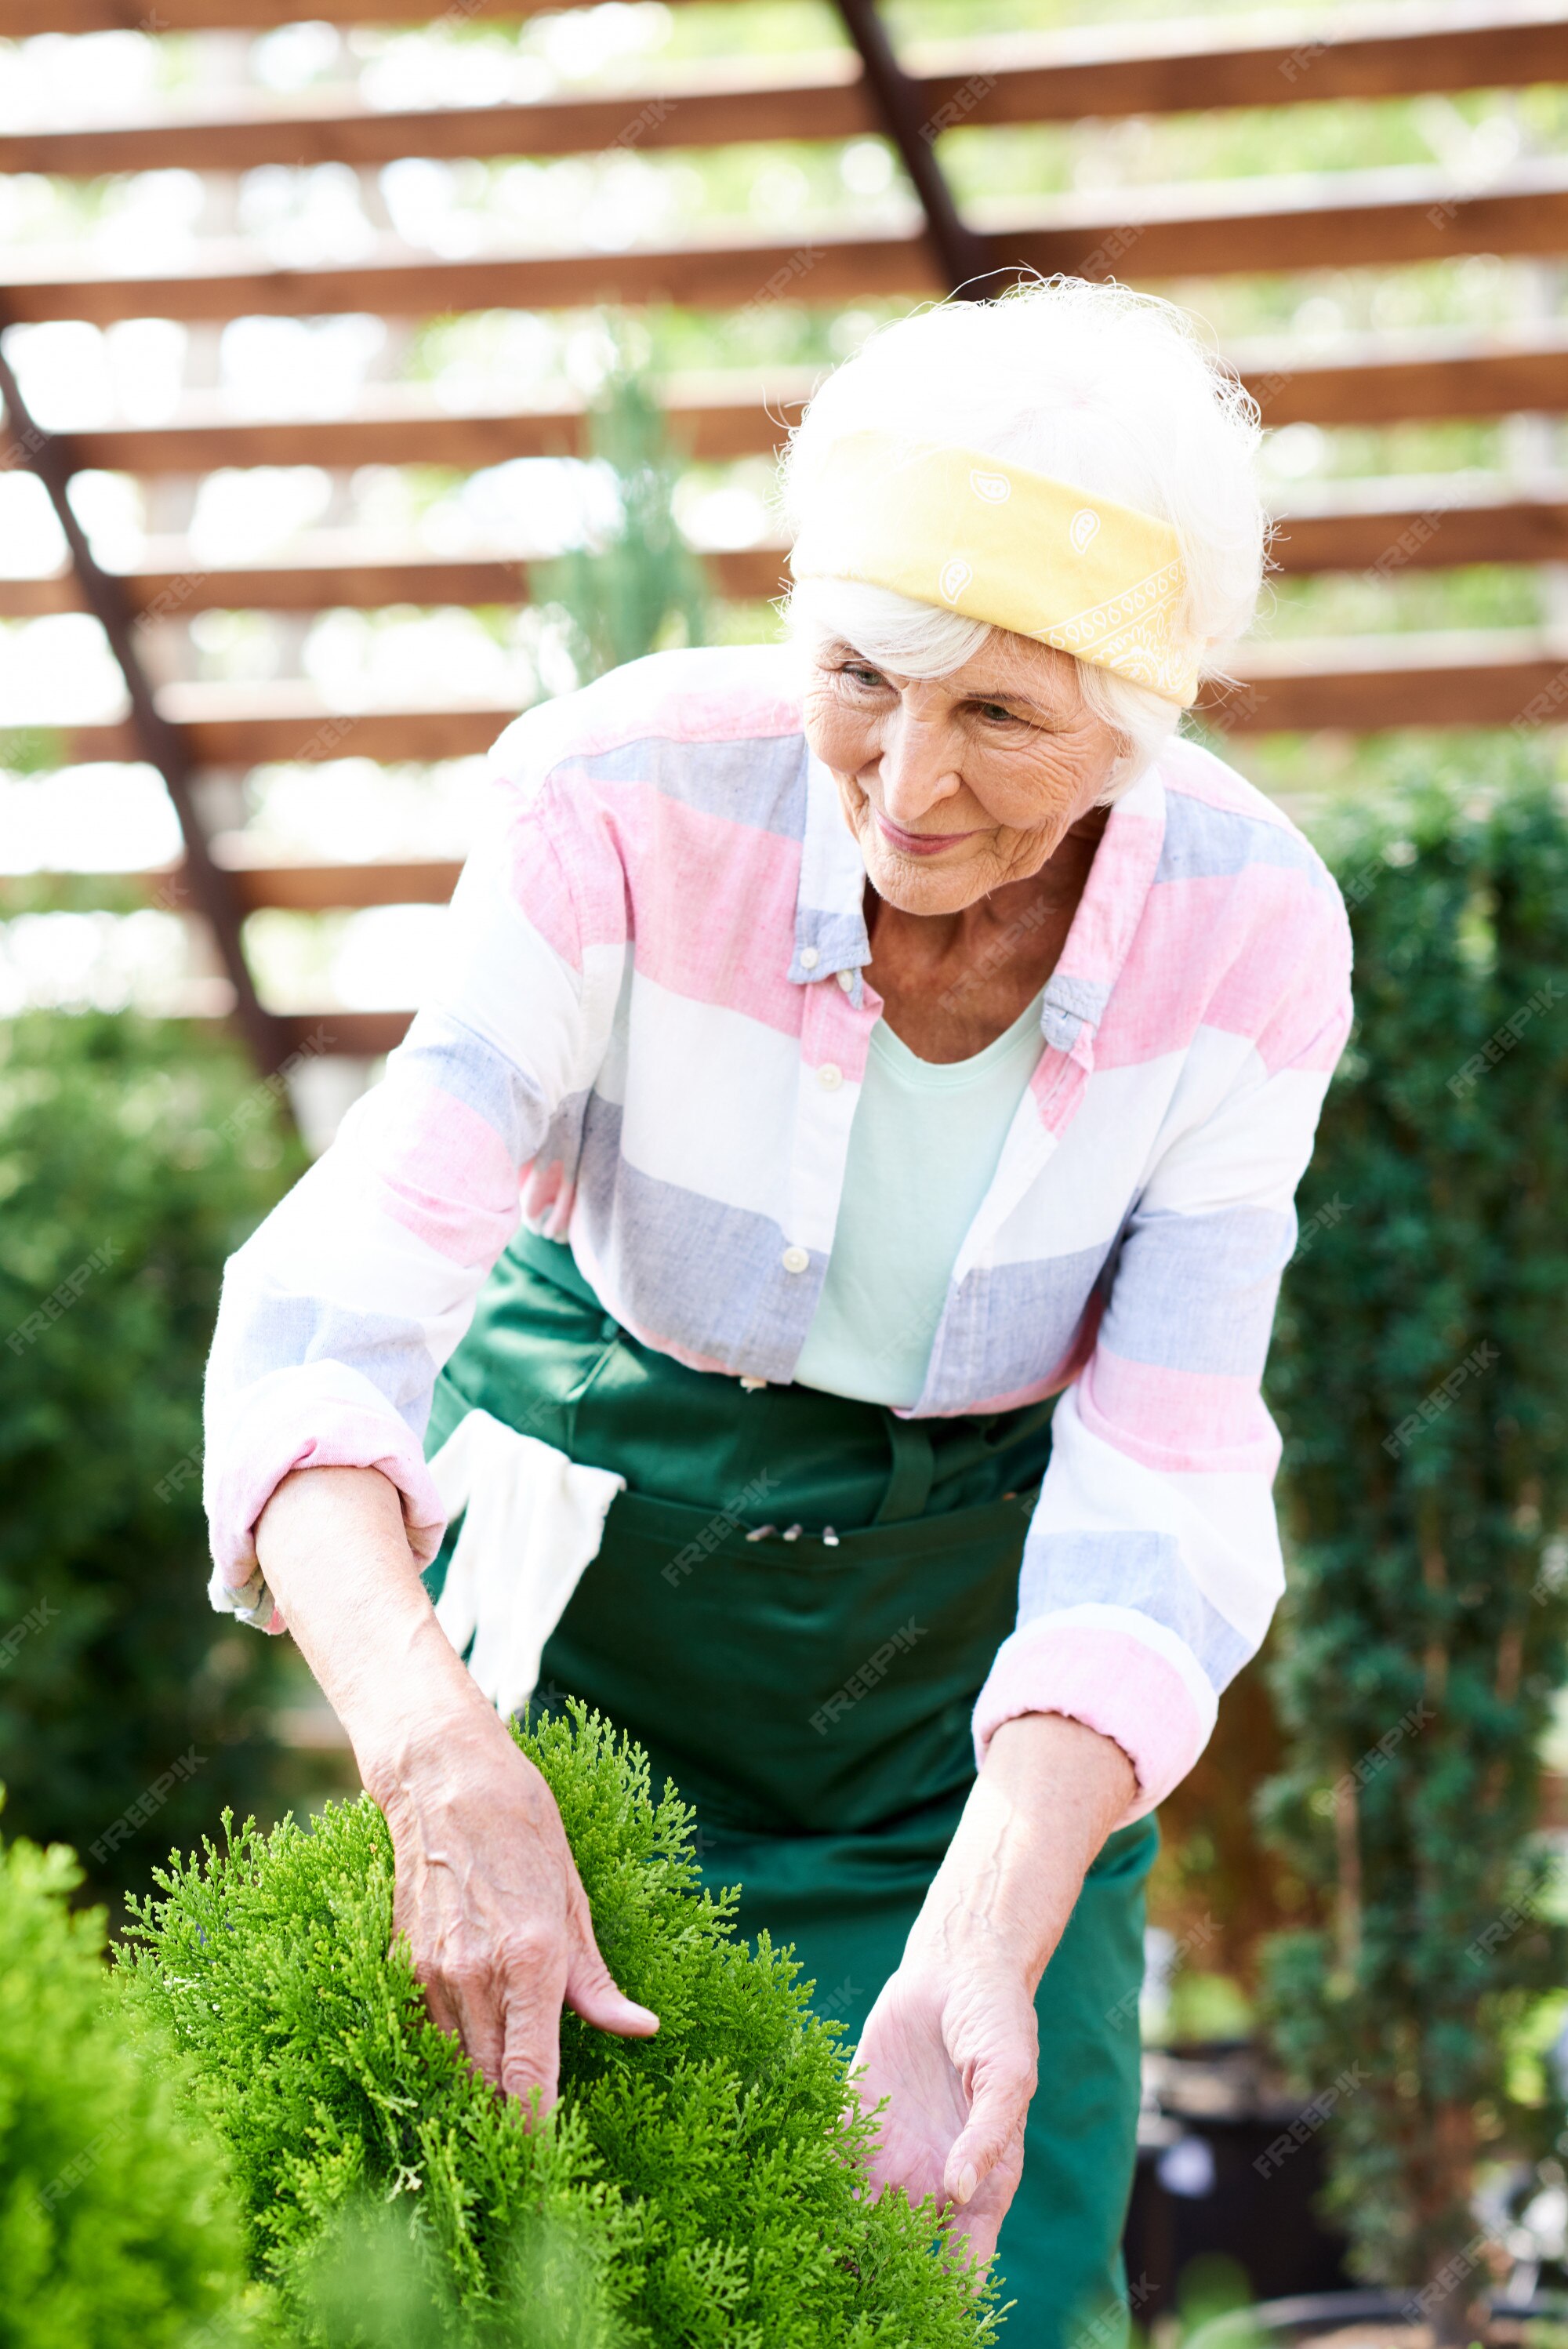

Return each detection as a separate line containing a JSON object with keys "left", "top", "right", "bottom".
{"left": 852, "top": 1712, "right": 1138, "bottom": 2264}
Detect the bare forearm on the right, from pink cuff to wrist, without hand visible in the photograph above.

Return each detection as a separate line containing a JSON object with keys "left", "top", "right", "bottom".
{"left": 911, "top": 1712, "right": 1138, "bottom": 1995}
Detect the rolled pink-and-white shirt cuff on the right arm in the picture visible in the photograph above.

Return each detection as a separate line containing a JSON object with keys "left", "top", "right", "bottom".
{"left": 975, "top": 1607, "right": 1216, "bottom": 1828}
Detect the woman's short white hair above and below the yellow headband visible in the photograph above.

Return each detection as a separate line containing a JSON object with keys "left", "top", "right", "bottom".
{"left": 782, "top": 278, "right": 1268, "bottom": 799}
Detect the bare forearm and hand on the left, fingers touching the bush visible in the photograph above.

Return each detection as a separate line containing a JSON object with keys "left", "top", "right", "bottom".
{"left": 256, "top": 1469, "right": 659, "bottom": 2111}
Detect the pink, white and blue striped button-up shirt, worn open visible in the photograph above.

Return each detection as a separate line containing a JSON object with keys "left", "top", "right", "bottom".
{"left": 206, "top": 648, "right": 1350, "bottom": 1816}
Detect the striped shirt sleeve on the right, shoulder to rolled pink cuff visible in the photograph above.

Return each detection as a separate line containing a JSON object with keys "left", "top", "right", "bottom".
{"left": 975, "top": 890, "right": 1350, "bottom": 1821}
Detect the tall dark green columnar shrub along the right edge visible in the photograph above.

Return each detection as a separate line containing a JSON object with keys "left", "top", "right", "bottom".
{"left": 1265, "top": 761, "right": 1568, "bottom": 2342}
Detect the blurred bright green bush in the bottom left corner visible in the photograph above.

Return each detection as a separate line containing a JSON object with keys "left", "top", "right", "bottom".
{"left": 0, "top": 1803, "right": 241, "bottom": 2349}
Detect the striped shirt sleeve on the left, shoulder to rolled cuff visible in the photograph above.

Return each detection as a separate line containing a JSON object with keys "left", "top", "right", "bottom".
{"left": 204, "top": 742, "right": 624, "bottom": 1630}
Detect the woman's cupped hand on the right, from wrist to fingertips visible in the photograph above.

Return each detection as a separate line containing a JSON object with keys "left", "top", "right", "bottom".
{"left": 855, "top": 1955, "right": 1040, "bottom": 2264}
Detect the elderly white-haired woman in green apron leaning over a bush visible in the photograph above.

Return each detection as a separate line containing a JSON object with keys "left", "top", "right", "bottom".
{"left": 209, "top": 282, "right": 1348, "bottom": 2349}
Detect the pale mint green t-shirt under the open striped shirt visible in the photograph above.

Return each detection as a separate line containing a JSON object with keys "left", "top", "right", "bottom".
{"left": 796, "top": 996, "right": 1042, "bottom": 1405}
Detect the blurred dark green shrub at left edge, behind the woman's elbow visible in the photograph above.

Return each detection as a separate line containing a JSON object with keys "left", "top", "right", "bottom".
{"left": 0, "top": 1015, "right": 296, "bottom": 1891}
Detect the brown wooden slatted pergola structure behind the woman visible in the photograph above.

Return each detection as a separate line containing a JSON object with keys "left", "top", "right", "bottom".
{"left": 0, "top": 0, "right": 1568, "bottom": 1052}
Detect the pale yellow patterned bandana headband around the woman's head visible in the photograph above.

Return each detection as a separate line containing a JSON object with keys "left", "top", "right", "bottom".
{"left": 789, "top": 432, "right": 1197, "bottom": 710}
